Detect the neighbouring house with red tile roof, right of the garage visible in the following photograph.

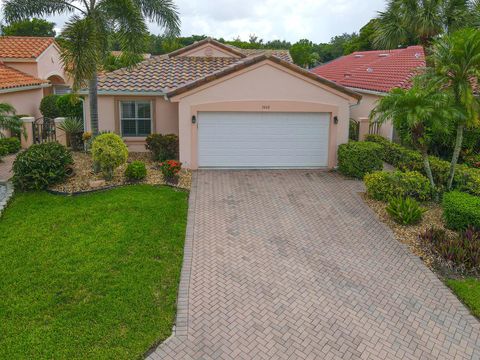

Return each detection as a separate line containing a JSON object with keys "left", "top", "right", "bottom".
{"left": 311, "top": 46, "right": 425, "bottom": 139}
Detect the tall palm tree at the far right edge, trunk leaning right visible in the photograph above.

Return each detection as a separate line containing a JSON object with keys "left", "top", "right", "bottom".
{"left": 432, "top": 29, "right": 480, "bottom": 190}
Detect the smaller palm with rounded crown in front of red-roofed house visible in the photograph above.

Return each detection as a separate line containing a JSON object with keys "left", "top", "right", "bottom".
{"left": 370, "top": 77, "right": 458, "bottom": 198}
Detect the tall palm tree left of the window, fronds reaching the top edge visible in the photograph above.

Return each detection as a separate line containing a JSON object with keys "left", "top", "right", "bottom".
{"left": 4, "top": 0, "right": 180, "bottom": 132}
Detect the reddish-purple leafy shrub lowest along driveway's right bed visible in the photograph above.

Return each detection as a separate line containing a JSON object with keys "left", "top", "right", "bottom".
{"left": 419, "top": 227, "right": 480, "bottom": 270}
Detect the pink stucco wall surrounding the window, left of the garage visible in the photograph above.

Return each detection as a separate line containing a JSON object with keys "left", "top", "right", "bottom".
{"left": 84, "top": 95, "right": 178, "bottom": 152}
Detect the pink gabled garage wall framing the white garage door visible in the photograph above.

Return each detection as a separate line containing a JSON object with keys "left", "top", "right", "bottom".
{"left": 172, "top": 60, "right": 355, "bottom": 169}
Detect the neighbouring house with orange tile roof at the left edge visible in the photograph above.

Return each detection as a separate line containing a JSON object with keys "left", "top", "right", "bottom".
{"left": 0, "top": 36, "right": 70, "bottom": 117}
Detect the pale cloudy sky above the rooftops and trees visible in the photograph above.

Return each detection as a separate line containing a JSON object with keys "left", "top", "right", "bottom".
{"left": 0, "top": 0, "right": 386, "bottom": 43}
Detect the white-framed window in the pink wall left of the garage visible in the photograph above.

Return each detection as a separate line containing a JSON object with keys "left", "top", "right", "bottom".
{"left": 120, "top": 101, "right": 152, "bottom": 136}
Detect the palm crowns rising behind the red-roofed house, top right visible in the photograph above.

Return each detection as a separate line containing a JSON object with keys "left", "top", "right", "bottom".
{"left": 375, "top": 0, "right": 470, "bottom": 52}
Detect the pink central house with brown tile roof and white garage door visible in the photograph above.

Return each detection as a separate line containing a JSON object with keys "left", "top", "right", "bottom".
{"left": 85, "top": 38, "right": 361, "bottom": 169}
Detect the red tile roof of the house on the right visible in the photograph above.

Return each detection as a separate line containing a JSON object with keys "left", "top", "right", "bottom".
{"left": 311, "top": 46, "right": 425, "bottom": 92}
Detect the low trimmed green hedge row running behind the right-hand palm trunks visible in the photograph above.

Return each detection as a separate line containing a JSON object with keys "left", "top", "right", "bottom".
{"left": 366, "top": 135, "right": 480, "bottom": 196}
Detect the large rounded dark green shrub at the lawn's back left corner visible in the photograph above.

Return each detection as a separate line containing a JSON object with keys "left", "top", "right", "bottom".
{"left": 13, "top": 142, "right": 73, "bottom": 190}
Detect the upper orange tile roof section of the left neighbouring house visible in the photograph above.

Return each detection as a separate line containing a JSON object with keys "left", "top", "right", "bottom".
{"left": 0, "top": 36, "right": 55, "bottom": 59}
